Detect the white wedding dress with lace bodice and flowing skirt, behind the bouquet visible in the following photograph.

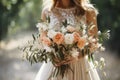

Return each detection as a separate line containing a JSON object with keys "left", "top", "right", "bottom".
{"left": 35, "top": 8, "right": 100, "bottom": 80}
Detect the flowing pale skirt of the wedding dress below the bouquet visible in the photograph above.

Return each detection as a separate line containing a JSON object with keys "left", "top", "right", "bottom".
{"left": 35, "top": 56, "right": 100, "bottom": 80}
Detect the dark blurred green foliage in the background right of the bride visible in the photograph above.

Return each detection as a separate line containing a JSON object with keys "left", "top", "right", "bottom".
{"left": 91, "top": 0, "right": 120, "bottom": 53}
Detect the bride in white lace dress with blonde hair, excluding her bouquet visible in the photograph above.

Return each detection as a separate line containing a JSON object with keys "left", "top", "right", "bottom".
{"left": 35, "top": 0, "right": 100, "bottom": 80}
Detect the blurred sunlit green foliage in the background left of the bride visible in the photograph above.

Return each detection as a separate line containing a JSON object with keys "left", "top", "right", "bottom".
{"left": 0, "top": 0, "right": 42, "bottom": 40}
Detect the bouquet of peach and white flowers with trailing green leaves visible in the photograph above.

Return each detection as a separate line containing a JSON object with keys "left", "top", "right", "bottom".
{"left": 22, "top": 20, "right": 109, "bottom": 77}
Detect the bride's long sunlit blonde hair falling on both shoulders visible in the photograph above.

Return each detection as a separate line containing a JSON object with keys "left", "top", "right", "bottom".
{"left": 43, "top": 0, "right": 98, "bottom": 14}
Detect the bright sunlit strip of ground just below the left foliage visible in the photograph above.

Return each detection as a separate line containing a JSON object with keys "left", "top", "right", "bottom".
{"left": 0, "top": 31, "right": 35, "bottom": 51}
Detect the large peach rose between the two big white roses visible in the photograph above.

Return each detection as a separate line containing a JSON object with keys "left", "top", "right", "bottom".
{"left": 53, "top": 32, "right": 64, "bottom": 44}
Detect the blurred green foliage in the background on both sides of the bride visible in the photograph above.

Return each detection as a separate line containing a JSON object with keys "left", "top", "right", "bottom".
{"left": 0, "top": 0, "right": 120, "bottom": 50}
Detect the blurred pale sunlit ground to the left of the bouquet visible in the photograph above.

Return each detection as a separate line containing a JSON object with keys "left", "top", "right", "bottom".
{"left": 0, "top": 31, "right": 41, "bottom": 80}
